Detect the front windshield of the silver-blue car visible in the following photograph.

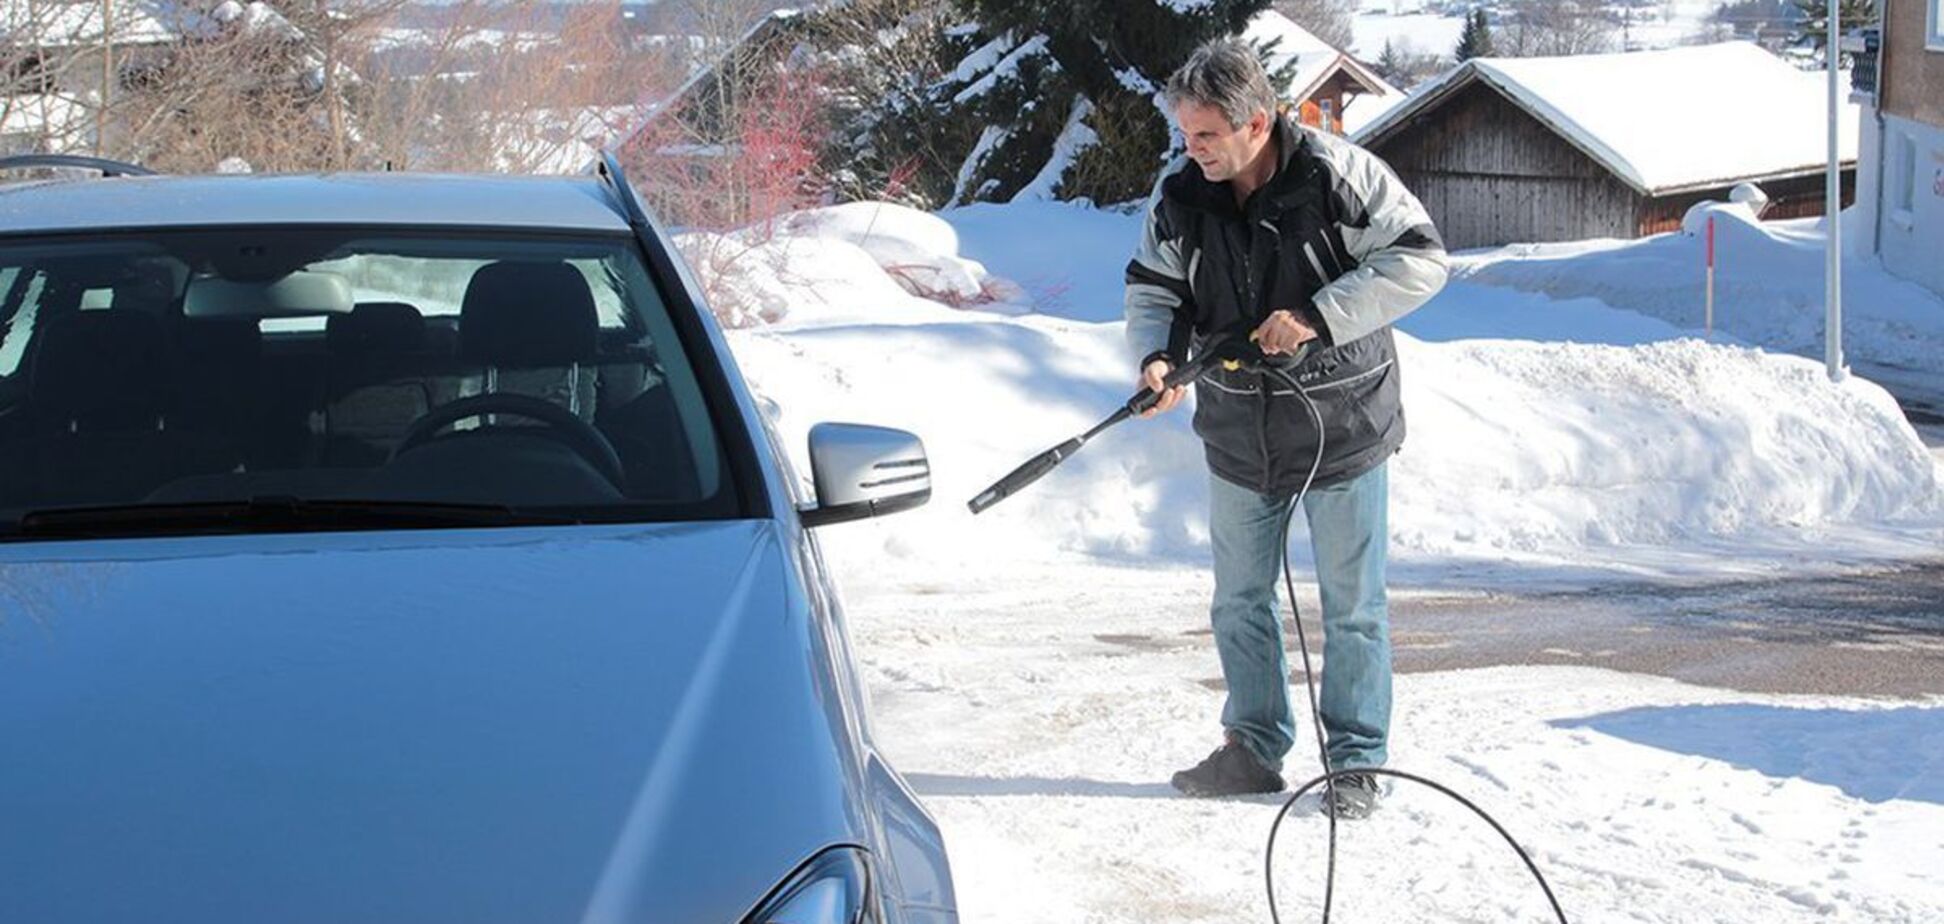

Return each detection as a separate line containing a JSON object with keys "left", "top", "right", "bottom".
{"left": 0, "top": 230, "right": 739, "bottom": 539}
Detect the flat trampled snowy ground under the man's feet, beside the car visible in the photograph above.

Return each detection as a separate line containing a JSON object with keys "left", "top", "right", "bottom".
{"left": 838, "top": 562, "right": 1944, "bottom": 924}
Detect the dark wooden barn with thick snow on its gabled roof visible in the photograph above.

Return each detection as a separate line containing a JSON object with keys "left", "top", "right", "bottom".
{"left": 1353, "top": 43, "right": 1858, "bottom": 249}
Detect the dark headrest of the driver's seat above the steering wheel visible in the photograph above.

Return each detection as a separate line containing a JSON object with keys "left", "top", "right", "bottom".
{"left": 459, "top": 261, "right": 601, "bottom": 368}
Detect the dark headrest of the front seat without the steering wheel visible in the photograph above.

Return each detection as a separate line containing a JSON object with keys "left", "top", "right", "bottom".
{"left": 29, "top": 309, "right": 177, "bottom": 428}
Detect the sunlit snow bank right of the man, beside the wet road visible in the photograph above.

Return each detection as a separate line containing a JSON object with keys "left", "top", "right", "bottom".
{"left": 1392, "top": 340, "right": 1944, "bottom": 556}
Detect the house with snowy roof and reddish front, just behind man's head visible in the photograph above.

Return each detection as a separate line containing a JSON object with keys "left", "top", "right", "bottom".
{"left": 1242, "top": 10, "right": 1404, "bottom": 134}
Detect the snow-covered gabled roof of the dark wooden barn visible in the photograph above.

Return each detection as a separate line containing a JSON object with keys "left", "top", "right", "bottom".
{"left": 1355, "top": 43, "right": 1860, "bottom": 195}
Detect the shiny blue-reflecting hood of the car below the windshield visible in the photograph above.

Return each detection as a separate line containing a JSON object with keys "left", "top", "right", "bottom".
{"left": 0, "top": 521, "right": 865, "bottom": 924}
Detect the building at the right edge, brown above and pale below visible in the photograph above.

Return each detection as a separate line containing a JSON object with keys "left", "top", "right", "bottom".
{"left": 1853, "top": 0, "right": 1944, "bottom": 296}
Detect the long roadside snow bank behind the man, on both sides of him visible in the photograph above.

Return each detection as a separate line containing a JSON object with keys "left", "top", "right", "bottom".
{"left": 735, "top": 317, "right": 1938, "bottom": 579}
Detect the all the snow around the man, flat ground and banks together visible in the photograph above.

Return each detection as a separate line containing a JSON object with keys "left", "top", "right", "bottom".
{"left": 682, "top": 202, "right": 1944, "bottom": 922}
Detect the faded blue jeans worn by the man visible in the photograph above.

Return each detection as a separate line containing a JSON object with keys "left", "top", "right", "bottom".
{"left": 1209, "top": 463, "right": 1390, "bottom": 770}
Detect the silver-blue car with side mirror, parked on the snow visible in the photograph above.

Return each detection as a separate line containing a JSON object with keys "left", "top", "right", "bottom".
{"left": 0, "top": 161, "right": 956, "bottom": 924}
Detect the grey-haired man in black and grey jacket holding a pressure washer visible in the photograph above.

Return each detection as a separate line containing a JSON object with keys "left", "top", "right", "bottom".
{"left": 1126, "top": 39, "right": 1446, "bottom": 817}
